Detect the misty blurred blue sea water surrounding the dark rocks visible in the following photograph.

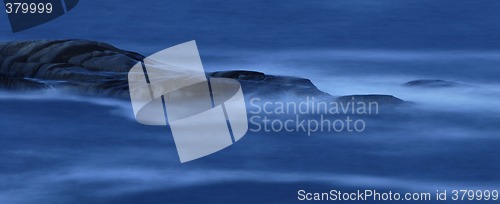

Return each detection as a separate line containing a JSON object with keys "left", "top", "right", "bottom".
{"left": 0, "top": 0, "right": 500, "bottom": 203}
